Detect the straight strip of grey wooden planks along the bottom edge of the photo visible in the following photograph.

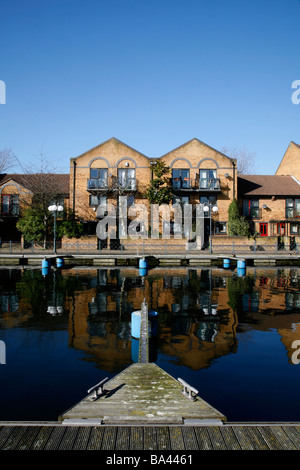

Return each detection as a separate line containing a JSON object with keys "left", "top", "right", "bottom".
{"left": 0, "top": 423, "right": 300, "bottom": 455}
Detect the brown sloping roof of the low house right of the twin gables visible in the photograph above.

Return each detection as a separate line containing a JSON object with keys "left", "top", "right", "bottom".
{"left": 238, "top": 175, "right": 300, "bottom": 197}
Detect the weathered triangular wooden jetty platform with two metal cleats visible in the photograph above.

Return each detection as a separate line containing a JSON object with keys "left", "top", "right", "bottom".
{"left": 59, "top": 363, "right": 226, "bottom": 425}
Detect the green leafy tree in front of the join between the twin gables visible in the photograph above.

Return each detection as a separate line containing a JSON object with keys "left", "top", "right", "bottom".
{"left": 144, "top": 160, "right": 173, "bottom": 205}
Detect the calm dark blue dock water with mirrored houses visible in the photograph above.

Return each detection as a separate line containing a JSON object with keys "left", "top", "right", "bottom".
{"left": 0, "top": 268, "right": 300, "bottom": 421}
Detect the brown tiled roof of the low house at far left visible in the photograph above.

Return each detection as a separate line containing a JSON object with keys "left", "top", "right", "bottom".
{"left": 0, "top": 173, "right": 70, "bottom": 194}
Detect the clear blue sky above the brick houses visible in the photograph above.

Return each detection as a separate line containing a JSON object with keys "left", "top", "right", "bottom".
{"left": 0, "top": 0, "right": 300, "bottom": 174}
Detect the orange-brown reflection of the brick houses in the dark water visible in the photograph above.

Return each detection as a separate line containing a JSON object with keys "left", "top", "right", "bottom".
{"left": 0, "top": 267, "right": 300, "bottom": 372}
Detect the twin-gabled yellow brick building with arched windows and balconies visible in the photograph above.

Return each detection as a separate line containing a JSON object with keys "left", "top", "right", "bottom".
{"left": 70, "top": 138, "right": 237, "bottom": 243}
